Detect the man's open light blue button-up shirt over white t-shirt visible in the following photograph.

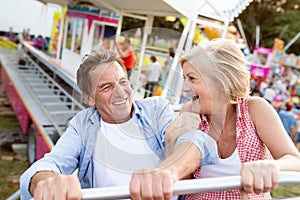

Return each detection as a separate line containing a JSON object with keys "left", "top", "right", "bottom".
{"left": 20, "top": 97, "right": 215, "bottom": 199}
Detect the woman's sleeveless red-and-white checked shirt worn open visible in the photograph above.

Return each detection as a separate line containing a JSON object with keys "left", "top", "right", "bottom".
{"left": 186, "top": 98, "right": 273, "bottom": 200}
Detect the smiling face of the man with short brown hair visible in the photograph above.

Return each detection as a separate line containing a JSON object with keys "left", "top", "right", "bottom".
{"left": 89, "top": 62, "right": 132, "bottom": 123}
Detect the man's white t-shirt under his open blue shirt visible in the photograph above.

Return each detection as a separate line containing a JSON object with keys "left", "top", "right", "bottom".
{"left": 93, "top": 119, "right": 161, "bottom": 187}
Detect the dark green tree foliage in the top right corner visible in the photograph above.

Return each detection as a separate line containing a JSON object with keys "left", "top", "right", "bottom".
{"left": 239, "top": 0, "right": 300, "bottom": 55}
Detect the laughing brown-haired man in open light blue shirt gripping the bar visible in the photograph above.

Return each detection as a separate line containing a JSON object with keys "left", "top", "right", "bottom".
{"left": 20, "top": 49, "right": 210, "bottom": 200}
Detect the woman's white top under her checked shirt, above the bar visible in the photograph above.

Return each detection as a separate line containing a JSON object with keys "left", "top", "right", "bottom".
{"left": 200, "top": 148, "right": 242, "bottom": 178}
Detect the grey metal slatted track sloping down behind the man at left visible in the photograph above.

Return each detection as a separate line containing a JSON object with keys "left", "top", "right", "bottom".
{"left": 1, "top": 48, "right": 84, "bottom": 146}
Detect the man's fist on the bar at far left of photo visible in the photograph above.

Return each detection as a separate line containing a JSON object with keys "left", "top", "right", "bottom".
{"left": 30, "top": 172, "right": 81, "bottom": 200}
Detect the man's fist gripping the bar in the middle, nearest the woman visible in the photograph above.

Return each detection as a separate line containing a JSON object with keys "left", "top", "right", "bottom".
{"left": 130, "top": 169, "right": 178, "bottom": 200}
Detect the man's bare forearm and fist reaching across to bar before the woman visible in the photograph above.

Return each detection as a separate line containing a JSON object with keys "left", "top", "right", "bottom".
{"left": 130, "top": 142, "right": 201, "bottom": 200}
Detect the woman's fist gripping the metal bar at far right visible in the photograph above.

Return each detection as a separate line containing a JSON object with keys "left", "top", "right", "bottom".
{"left": 241, "top": 160, "right": 280, "bottom": 194}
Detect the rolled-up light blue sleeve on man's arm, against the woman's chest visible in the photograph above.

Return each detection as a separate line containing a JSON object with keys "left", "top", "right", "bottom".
{"left": 176, "top": 130, "right": 219, "bottom": 166}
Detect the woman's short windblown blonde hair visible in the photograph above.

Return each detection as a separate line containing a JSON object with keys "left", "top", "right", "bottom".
{"left": 180, "top": 39, "right": 250, "bottom": 104}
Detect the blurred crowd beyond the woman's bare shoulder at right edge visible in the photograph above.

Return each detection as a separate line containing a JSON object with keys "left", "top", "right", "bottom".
{"left": 251, "top": 67, "right": 300, "bottom": 150}
